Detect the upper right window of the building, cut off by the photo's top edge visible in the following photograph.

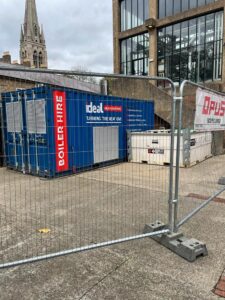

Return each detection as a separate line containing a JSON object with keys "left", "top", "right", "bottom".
{"left": 158, "top": 0, "right": 217, "bottom": 19}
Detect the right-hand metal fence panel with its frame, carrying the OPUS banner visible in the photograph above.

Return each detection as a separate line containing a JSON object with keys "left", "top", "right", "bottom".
{"left": 174, "top": 80, "right": 225, "bottom": 230}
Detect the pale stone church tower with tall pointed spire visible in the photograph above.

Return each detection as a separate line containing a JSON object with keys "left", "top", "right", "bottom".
{"left": 20, "top": 0, "right": 48, "bottom": 68}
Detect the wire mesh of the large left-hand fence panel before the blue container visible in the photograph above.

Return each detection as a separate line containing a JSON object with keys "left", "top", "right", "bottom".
{"left": 0, "top": 67, "right": 170, "bottom": 264}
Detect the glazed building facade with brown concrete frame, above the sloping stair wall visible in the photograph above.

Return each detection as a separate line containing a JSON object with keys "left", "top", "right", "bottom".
{"left": 113, "top": 0, "right": 225, "bottom": 86}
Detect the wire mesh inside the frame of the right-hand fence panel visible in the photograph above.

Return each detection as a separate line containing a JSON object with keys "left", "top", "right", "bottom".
{"left": 175, "top": 82, "right": 225, "bottom": 227}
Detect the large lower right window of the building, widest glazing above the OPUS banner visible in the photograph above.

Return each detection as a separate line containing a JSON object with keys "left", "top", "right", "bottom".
{"left": 158, "top": 11, "right": 223, "bottom": 82}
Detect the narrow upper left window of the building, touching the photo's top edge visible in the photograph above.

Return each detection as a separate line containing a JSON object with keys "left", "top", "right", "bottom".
{"left": 120, "top": 0, "right": 149, "bottom": 31}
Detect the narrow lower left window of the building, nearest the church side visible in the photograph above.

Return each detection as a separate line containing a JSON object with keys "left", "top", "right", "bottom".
{"left": 121, "top": 33, "right": 149, "bottom": 75}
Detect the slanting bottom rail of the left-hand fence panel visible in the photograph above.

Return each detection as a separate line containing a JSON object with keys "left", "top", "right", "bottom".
{"left": 0, "top": 229, "right": 169, "bottom": 269}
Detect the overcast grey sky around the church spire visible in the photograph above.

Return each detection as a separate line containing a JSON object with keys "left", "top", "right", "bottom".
{"left": 0, "top": 0, "right": 113, "bottom": 72}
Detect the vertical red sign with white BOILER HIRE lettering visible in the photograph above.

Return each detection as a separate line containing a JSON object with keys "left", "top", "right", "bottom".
{"left": 53, "top": 91, "right": 69, "bottom": 172}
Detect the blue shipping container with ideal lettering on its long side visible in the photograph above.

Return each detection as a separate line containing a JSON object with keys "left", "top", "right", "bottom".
{"left": 2, "top": 87, "right": 154, "bottom": 177}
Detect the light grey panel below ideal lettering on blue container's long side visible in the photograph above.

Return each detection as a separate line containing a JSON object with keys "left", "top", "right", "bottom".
{"left": 93, "top": 126, "right": 119, "bottom": 164}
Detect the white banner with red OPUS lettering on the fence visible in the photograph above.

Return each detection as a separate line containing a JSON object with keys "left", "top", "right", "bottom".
{"left": 194, "top": 88, "right": 225, "bottom": 131}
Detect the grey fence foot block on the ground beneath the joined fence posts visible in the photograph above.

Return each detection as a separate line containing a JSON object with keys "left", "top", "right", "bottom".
{"left": 144, "top": 221, "right": 208, "bottom": 262}
